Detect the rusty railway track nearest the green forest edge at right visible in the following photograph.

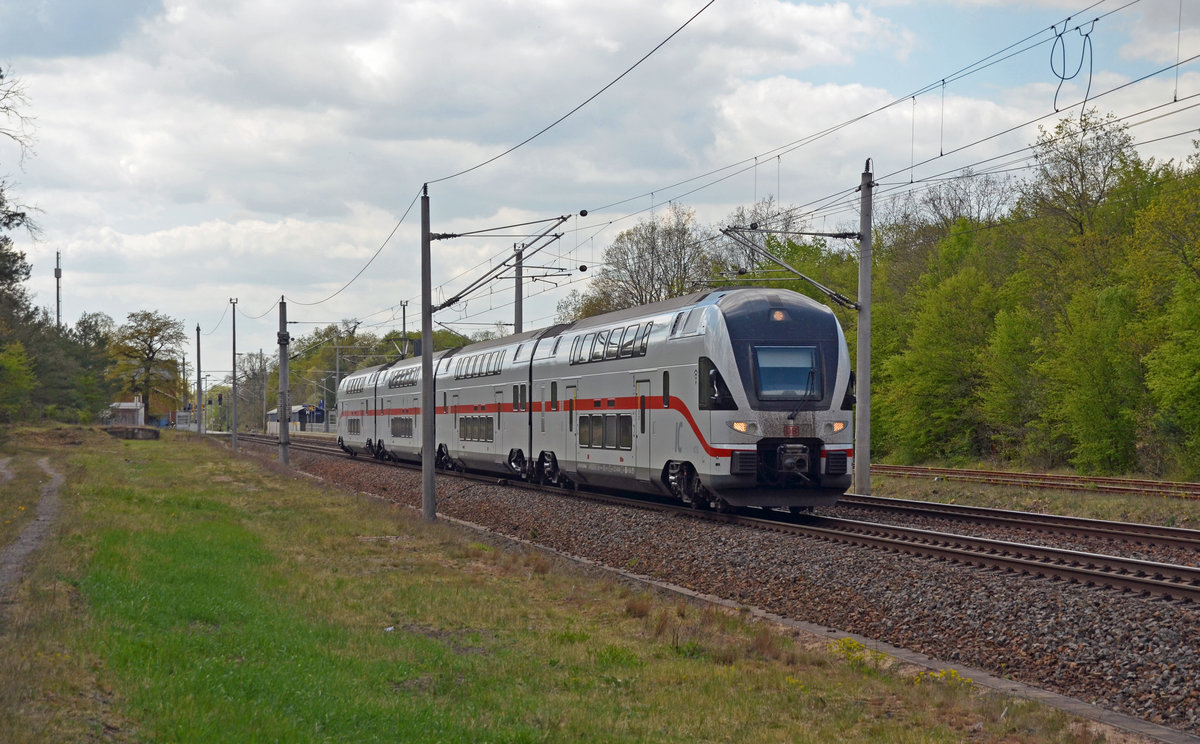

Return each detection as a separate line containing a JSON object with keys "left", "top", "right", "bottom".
{"left": 871, "top": 464, "right": 1200, "bottom": 499}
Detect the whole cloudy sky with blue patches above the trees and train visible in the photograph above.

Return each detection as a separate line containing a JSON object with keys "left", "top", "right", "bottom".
{"left": 0, "top": 0, "right": 1200, "bottom": 391}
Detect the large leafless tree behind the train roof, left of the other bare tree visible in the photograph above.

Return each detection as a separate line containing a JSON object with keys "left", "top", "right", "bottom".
{"left": 558, "top": 204, "right": 712, "bottom": 322}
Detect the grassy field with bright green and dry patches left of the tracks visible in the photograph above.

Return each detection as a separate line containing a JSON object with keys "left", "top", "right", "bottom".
{"left": 0, "top": 430, "right": 1112, "bottom": 743}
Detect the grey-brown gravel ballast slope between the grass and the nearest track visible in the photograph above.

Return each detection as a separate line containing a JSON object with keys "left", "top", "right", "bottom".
{"left": 238, "top": 432, "right": 1200, "bottom": 740}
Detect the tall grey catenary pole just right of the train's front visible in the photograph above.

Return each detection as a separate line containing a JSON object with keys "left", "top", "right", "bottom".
{"left": 854, "top": 158, "right": 875, "bottom": 496}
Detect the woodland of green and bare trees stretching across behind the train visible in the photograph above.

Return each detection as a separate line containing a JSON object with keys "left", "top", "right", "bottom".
{"left": 0, "top": 93, "right": 1200, "bottom": 480}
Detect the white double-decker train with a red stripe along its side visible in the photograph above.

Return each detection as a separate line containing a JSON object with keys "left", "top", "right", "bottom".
{"left": 337, "top": 287, "right": 854, "bottom": 511}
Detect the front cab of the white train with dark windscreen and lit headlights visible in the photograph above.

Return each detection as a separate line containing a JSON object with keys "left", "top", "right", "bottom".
{"left": 697, "top": 293, "right": 854, "bottom": 508}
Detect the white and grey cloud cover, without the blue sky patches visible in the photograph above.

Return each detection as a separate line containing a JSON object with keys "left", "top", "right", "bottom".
{"left": 9, "top": 0, "right": 1200, "bottom": 364}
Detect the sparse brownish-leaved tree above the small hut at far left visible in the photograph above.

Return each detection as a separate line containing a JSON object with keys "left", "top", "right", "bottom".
{"left": 113, "top": 310, "right": 187, "bottom": 418}
